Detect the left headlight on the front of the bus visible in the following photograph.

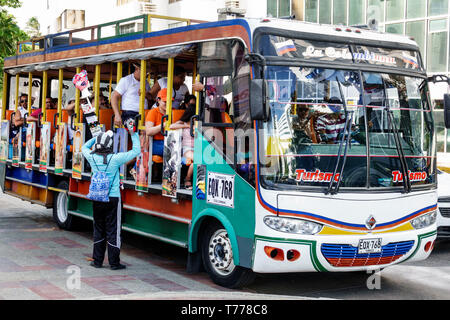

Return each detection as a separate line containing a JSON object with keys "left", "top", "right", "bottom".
{"left": 264, "top": 216, "right": 323, "bottom": 234}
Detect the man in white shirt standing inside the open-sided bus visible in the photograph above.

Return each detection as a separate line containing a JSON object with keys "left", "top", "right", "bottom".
{"left": 111, "top": 62, "right": 152, "bottom": 126}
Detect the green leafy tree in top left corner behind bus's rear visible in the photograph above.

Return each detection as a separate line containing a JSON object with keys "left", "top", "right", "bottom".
{"left": 0, "top": 0, "right": 29, "bottom": 95}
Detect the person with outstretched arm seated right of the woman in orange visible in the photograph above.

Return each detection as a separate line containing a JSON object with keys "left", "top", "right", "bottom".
{"left": 170, "top": 94, "right": 196, "bottom": 190}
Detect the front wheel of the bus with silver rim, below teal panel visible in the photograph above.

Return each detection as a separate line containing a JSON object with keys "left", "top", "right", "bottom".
{"left": 202, "top": 223, "right": 255, "bottom": 289}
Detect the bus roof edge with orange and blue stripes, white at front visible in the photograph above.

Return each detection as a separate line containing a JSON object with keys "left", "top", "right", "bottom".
{"left": 4, "top": 16, "right": 418, "bottom": 74}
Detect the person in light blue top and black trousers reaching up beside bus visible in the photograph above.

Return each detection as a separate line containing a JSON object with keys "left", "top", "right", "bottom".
{"left": 82, "top": 121, "right": 141, "bottom": 270}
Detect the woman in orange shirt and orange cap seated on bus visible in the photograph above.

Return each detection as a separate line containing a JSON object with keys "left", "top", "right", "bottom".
{"left": 145, "top": 88, "right": 171, "bottom": 157}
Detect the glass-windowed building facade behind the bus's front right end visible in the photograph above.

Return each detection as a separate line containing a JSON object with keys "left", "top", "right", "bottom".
{"left": 298, "top": 0, "right": 450, "bottom": 169}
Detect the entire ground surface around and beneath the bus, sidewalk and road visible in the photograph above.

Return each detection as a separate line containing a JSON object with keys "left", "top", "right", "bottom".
{"left": 0, "top": 194, "right": 450, "bottom": 300}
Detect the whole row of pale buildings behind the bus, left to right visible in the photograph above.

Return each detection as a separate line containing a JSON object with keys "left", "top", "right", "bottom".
{"left": 37, "top": 0, "right": 450, "bottom": 169}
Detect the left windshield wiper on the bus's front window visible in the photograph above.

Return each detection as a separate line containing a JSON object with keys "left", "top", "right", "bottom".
{"left": 325, "top": 81, "right": 354, "bottom": 194}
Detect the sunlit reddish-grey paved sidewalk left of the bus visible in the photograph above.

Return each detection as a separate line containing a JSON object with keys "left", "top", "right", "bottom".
{"left": 0, "top": 194, "right": 318, "bottom": 300}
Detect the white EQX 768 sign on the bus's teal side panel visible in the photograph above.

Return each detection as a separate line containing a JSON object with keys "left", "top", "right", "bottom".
{"left": 206, "top": 172, "right": 234, "bottom": 208}
